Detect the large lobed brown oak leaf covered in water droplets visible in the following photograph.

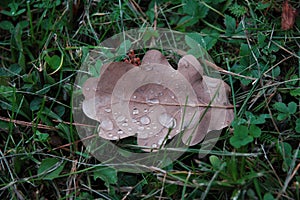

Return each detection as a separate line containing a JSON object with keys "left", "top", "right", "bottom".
{"left": 82, "top": 50, "right": 233, "bottom": 151}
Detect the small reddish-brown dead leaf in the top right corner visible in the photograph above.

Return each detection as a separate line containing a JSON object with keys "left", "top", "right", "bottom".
{"left": 281, "top": 0, "right": 297, "bottom": 30}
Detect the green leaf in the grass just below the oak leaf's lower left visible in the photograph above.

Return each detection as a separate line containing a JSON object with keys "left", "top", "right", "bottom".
{"left": 94, "top": 167, "right": 118, "bottom": 187}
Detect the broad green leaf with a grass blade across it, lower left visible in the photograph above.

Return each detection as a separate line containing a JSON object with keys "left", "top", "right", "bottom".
{"left": 38, "top": 158, "right": 65, "bottom": 180}
